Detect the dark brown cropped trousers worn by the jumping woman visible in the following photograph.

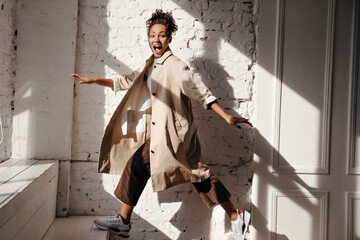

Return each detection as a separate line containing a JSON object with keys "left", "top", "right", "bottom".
{"left": 114, "top": 139, "right": 231, "bottom": 208}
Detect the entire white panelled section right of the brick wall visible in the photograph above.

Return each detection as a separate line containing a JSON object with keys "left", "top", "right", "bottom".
{"left": 252, "top": 0, "right": 360, "bottom": 240}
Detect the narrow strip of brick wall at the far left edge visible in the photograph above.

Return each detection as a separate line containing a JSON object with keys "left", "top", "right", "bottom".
{"left": 0, "top": 0, "right": 16, "bottom": 162}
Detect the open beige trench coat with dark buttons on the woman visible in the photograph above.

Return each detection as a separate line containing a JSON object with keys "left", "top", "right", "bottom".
{"left": 98, "top": 49, "right": 216, "bottom": 191}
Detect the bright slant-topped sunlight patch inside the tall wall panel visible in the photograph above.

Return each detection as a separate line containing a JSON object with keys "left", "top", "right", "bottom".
{"left": 279, "top": 84, "right": 322, "bottom": 166}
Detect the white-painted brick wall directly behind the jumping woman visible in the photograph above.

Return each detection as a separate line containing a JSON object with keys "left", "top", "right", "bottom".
{"left": 69, "top": 0, "right": 257, "bottom": 239}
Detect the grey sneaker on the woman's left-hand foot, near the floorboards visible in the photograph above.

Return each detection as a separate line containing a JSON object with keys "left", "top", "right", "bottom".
{"left": 94, "top": 212, "right": 131, "bottom": 238}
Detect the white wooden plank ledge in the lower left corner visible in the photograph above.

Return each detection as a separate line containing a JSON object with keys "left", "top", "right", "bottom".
{"left": 0, "top": 159, "right": 59, "bottom": 239}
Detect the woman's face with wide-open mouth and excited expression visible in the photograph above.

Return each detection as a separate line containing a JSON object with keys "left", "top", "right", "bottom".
{"left": 148, "top": 24, "right": 171, "bottom": 58}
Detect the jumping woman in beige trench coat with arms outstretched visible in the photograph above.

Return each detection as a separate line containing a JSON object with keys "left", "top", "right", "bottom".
{"left": 70, "top": 9, "right": 252, "bottom": 239}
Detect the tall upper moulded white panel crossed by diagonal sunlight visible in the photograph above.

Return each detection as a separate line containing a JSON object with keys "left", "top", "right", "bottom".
{"left": 273, "top": 0, "right": 334, "bottom": 173}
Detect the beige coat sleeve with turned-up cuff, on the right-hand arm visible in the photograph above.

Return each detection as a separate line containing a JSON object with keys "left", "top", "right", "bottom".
{"left": 176, "top": 62, "right": 217, "bottom": 109}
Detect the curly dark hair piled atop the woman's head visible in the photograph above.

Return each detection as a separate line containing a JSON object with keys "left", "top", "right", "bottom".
{"left": 146, "top": 9, "right": 177, "bottom": 37}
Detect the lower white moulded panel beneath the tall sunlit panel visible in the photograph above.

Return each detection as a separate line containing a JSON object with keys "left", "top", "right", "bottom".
{"left": 271, "top": 190, "right": 328, "bottom": 240}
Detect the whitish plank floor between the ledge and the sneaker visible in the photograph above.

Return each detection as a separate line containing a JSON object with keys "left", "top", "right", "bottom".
{"left": 43, "top": 216, "right": 107, "bottom": 240}
